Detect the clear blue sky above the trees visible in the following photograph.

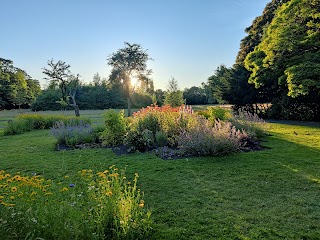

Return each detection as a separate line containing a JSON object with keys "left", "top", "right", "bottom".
{"left": 0, "top": 0, "right": 270, "bottom": 89}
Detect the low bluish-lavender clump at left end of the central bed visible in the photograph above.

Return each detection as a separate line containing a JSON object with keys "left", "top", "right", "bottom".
{"left": 50, "top": 120, "right": 95, "bottom": 147}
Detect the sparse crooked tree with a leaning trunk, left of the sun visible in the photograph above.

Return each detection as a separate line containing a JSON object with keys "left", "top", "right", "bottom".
{"left": 43, "top": 59, "right": 80, "bottom": 117}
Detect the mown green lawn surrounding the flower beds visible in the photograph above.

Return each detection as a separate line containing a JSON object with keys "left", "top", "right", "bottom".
{"left": 0, "top": 111, "right": 320, "bottom": 240}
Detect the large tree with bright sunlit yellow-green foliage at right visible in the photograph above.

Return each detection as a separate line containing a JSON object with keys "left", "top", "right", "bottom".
{"left": 245, "top": 0, "right": 320, "bottom": 98}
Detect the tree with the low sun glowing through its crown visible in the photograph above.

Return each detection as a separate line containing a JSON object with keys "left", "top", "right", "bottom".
{"left": 107, "top": 42, "right": 151, "bottom": 116}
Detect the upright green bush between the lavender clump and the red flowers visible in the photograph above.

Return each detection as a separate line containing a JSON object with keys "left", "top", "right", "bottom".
{"left": 100, "top": 109, "right": 127, "bottom": 146}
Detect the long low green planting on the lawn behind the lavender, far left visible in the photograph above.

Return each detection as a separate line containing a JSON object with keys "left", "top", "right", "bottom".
{"left": 4, "top": 113, "right": 90, "bottom": 135}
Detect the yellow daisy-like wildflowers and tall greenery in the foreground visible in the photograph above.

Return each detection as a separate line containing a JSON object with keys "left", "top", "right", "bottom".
{"left": 0, "top": 166, "right": 151, "bottom": 239}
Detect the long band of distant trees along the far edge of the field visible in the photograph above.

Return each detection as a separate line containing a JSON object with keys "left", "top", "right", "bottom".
{"left": 0, "top": 56, "right": 217, "bottom": 112}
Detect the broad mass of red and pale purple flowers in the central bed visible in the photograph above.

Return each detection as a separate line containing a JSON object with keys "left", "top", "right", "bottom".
{"left": 126, "top": 105, "right": 259, "bottom": 159}
